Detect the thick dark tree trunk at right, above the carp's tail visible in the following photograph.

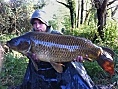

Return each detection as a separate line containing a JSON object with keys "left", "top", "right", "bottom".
{"left": 93, "top": 0, "right": 108, "bottom": 42}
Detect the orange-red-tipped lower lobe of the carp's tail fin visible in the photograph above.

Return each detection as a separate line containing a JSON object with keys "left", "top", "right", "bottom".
{"left": 97, "top": 51, "right": 115, "bottom": 76}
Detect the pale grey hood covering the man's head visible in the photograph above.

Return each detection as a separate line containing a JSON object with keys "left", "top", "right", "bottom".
{"left": 30, "top": 10, "right": 48, "bottom": 26}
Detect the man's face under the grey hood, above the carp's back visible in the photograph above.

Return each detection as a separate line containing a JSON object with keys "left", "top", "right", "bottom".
{"left": 33, "top": 19, "right": 47, "bottom": 32}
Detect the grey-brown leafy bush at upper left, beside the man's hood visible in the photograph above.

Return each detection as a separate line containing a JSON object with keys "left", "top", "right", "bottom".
{"left": 0, "top": 0, "right": 33, "bottom": 35}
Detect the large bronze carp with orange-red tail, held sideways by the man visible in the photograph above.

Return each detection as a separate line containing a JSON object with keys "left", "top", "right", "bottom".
{"left": 7, "top": 32, "right": 114, "bottom": 75}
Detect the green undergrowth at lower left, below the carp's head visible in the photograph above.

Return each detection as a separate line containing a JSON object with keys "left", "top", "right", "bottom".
{"left": 0, "top": 52, "right": 27, "bottom": 89}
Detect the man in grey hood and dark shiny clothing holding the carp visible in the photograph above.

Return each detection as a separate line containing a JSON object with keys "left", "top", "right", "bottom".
{"left": 15, "top": 10, "right": 96, "bottom": 89}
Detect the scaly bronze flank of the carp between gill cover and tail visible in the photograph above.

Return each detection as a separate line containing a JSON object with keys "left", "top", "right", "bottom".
{"left": 28, "top": 33, "right": 102, "bottom": 62}
